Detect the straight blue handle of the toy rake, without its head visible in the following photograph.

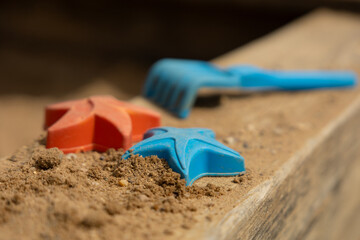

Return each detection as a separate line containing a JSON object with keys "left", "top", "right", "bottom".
{"left": 229, "top": 66, "right": 356, "bottom": 91}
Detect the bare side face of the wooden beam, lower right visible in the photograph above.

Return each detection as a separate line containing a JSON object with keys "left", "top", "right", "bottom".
{"left": 210, "top": 98, "right": 360, "bottom": 239}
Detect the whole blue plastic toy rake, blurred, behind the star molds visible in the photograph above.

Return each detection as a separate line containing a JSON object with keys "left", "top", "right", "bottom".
{"left": 144, "top": 59, "right": 356, "bottom": 118}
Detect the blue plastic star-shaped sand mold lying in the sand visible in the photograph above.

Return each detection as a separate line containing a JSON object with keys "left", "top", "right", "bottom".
{"left": 123, "top": 127, "right": 245, "bottom": 186}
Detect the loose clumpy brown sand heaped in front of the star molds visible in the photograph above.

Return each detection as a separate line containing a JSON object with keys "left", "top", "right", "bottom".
{"left": 0, "top": 137, "right": 229, "bottom": 239}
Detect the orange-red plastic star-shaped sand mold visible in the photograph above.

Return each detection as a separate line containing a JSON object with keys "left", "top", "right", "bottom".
{"left": 45, "top": 96, "right": 160, "bottom": 153}
